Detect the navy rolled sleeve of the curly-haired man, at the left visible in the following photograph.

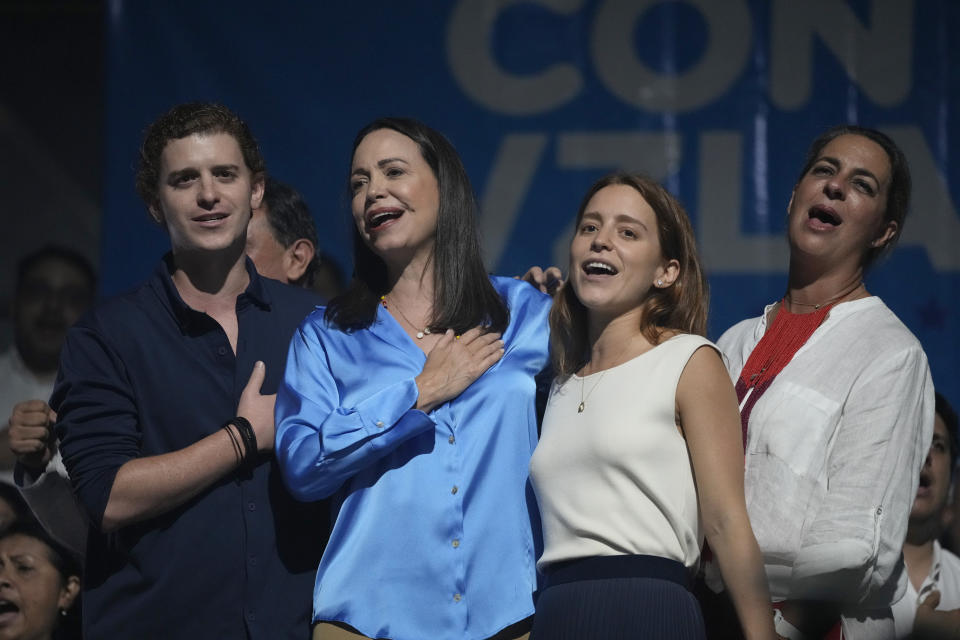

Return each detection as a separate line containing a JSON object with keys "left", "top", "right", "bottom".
{"left": 51, "top": 326, "right": 141, "bottom": 527}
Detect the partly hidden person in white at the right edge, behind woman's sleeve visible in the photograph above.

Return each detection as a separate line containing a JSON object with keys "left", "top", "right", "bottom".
{"left": 893, "top": 393, "right": 960, "bottom": 640}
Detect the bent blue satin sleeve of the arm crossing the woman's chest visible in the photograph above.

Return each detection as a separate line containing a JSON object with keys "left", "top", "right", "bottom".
{"left": 275, "top": 312, "right": 435, "bottom": 501}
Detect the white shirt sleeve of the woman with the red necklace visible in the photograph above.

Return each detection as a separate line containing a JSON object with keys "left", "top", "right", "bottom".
{"left": 791, "top": 346, "right": 934, "bottom": 606}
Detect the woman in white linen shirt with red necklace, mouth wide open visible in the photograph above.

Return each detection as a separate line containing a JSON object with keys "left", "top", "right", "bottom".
{"left": 708, "top": 126, "right": 933, "bottom": 640}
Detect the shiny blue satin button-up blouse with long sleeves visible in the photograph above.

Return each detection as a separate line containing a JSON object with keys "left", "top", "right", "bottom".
{"left": 276, "top": 277, "right": 550, "bottom": 640}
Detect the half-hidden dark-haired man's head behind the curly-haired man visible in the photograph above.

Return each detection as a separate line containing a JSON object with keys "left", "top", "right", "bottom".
{"left": 246, "top": 177, "right": 319, "bottom": 289}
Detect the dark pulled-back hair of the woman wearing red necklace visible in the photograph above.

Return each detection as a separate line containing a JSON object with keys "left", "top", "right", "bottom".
{"left": 797, "top": 124, "right": 912, "bottom": 271}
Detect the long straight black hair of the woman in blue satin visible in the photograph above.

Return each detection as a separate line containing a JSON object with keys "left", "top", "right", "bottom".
{"left": 325, "top": 118, "right": 510, "bottom": 333}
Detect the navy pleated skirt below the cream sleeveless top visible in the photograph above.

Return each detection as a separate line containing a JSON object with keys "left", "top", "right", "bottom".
{"left": 530, "top": 556, "right": 706, "bottom": 640}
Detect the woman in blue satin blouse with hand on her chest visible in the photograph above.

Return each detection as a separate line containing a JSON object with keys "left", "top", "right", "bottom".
{"left": 276, "top": 118, "right": 550, "bottom": 640}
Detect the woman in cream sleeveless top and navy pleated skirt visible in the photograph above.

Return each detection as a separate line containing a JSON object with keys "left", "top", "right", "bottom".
{"left": 530, "top": 174, "right": 775, "bottom": 640}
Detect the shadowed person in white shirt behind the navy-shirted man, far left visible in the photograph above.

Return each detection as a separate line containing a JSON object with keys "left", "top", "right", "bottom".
{"left": 0, "top": 245, "right": 97, "bottom": 479}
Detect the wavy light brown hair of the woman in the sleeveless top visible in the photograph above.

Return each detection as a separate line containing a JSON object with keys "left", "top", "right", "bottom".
{"left": 550, "top": 172, "right": 709, "bottom": 376}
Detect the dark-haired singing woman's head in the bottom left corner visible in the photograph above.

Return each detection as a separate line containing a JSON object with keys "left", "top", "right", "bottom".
{"left": 0, "top": 522, "right": 81, "bottom": 640}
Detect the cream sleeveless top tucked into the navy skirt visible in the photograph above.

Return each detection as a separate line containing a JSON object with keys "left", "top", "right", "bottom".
{"left": 530, "top": 334, "right": 716, "bottom": 570}
